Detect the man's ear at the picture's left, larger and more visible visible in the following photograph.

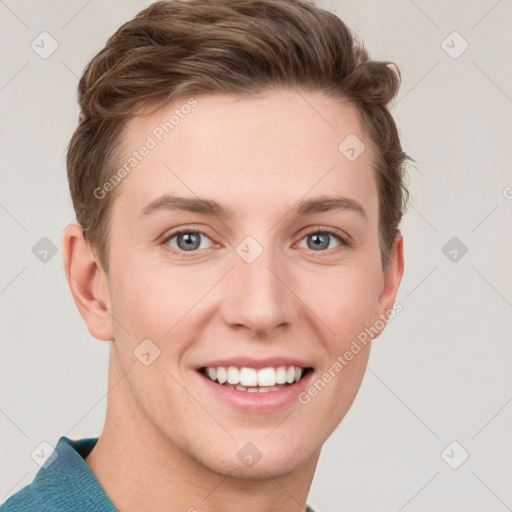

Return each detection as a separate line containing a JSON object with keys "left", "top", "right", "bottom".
{"left": 62, "top": 224, "right": 114, "bottom": 341}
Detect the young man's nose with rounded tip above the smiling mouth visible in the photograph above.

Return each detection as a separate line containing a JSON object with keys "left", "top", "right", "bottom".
{"left": 221, "top": 240, "right": 297, "bottom": 337}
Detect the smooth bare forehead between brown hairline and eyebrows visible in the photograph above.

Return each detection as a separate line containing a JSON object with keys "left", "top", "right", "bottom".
{"left": 110, "top": 89, "right": 376, "bottom": 220}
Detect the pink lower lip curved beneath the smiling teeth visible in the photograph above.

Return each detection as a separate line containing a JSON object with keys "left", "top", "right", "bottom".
{"left": 196, "top": 370, "right": 314, "bottom": 412}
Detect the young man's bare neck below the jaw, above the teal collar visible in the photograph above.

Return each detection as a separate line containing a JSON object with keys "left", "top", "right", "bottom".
{"left": 85, "top": 346, "right": 320, "bottom": 512}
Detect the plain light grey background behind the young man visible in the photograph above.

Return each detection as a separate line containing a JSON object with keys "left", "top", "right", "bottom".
{"left": 0, "top": 0, "right": 512, "bottom": 512}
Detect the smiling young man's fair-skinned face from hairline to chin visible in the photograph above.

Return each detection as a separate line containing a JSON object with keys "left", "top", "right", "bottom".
{"left": 77, "top": 90, "right": 402, "bottom": 479}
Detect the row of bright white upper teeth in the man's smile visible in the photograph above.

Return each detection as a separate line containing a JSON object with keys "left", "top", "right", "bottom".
{"left": 206, "top": 366, "right": 302, "bottom": 386}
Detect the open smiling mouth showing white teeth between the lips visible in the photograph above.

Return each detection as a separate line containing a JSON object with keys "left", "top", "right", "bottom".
{"left": 197, "top": 365, "right": 313, "bottom": 393}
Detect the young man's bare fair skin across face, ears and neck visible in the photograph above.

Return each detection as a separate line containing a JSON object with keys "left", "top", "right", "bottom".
{"left": 63, "top": 89, "right": 403, "bottom": 512}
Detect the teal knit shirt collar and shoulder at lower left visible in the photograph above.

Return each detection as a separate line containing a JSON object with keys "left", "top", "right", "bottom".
{"left": 0, "top": 436, "right": 315, "bottom": 512}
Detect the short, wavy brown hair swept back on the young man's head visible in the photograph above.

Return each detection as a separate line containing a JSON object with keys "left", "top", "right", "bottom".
{"left": 67, "top": 0, "right": 409, "bottom": 271}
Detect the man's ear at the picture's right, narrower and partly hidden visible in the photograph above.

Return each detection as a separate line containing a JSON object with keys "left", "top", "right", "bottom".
{"left": 374, "top": 233, "right": 404, "bottom": 337}
